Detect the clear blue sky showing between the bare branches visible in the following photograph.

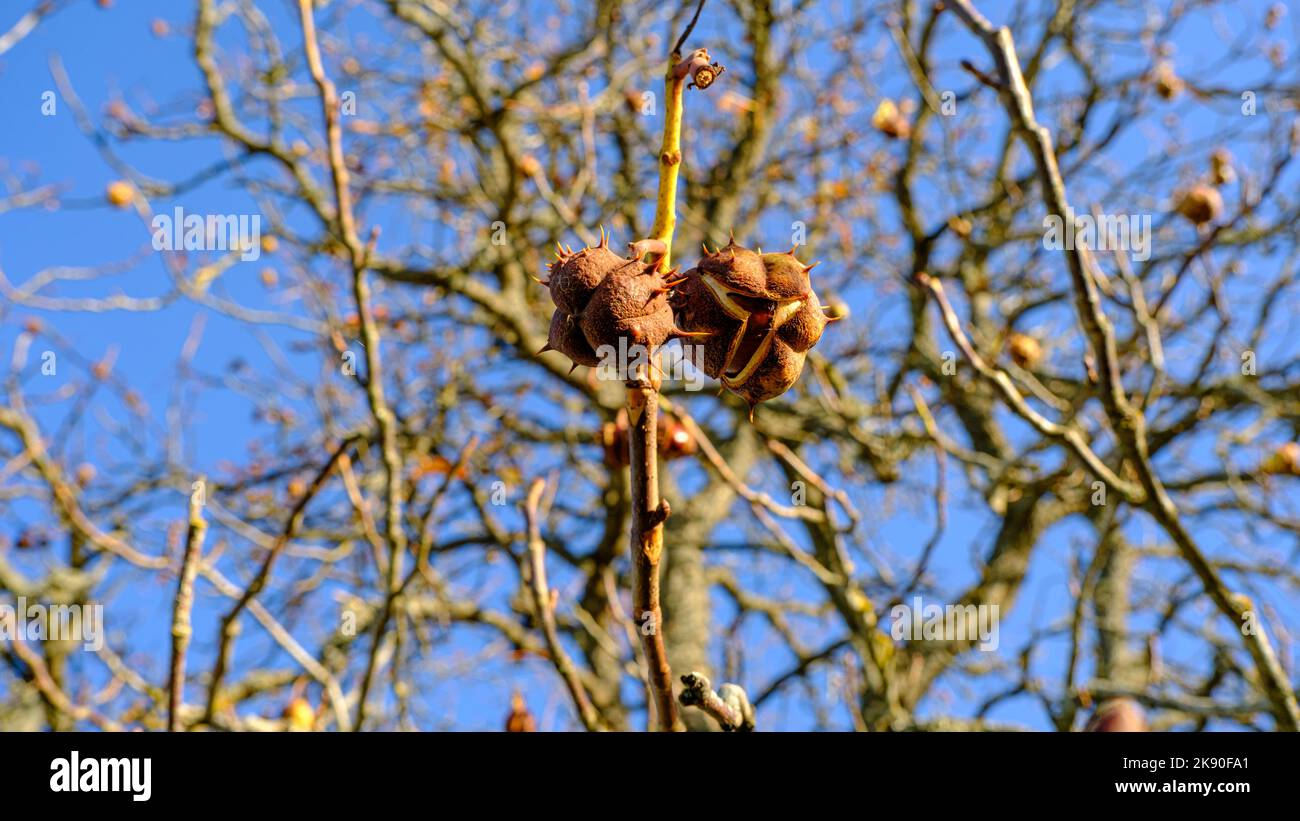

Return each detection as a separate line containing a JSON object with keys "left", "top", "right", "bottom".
{"left": 0, "top": 0, "right": 1300, "bottom": 729}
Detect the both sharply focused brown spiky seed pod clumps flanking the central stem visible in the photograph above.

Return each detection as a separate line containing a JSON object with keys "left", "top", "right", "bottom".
{"left": 542, "top": 231, "right": 839, "bottom": 417}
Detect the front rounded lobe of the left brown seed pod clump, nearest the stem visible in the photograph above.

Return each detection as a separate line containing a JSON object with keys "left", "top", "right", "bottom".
{"left": 581, "top": 260, "right": 673, "bottom": 352}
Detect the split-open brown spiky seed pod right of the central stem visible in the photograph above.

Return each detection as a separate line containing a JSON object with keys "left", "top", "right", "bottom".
{"left": 672, "top": 240, "right": 828, "bottom": 408}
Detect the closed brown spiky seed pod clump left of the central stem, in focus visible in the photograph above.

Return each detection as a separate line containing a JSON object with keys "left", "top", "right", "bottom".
{"left": 542, "top": 230, "right": 680, "bottom": 368}
